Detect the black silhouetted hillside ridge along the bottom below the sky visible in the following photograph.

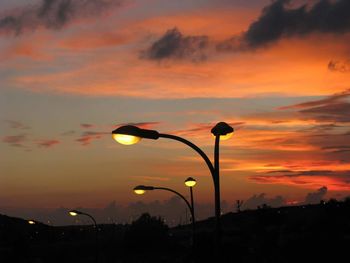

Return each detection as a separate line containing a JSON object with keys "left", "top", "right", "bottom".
{"left": 0, "top": 199, "right": 350, "bottom": 263}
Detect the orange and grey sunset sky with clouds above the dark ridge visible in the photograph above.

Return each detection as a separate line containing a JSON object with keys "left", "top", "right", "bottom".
{"left": 0, "top": 0, "right": 350, "bottom": 225}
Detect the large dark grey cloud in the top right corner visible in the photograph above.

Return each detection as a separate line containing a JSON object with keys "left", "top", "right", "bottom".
{"left": 217, "top": 0, "right": 350, "bottom": 51}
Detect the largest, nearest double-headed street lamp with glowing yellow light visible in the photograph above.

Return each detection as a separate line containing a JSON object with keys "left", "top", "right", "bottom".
{"left": 112, "top": 122, "right": 233, "bottom": 247}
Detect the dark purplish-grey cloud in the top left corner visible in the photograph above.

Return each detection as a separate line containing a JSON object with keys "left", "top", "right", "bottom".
{"left": 0, "top": 0, "right": 122, "bottom": 35}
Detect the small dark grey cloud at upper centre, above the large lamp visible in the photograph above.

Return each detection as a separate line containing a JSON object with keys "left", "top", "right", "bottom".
{"left": 141, "top": 28, "right": 209, "bottom": 61}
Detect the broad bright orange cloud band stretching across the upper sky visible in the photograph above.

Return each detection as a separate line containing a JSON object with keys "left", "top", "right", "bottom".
{"left": 13, "top": 34, "right": 350, "bottom": 98}
